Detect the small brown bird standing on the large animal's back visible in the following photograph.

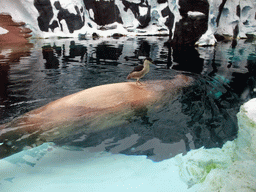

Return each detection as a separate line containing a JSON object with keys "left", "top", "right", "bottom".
{"left": 127, "top": 57, "right": 154, "bottom": 85}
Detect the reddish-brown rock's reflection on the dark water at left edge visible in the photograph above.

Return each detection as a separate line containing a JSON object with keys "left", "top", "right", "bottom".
{"left": 0, "top": 43, "right": 33, "bottom": 119}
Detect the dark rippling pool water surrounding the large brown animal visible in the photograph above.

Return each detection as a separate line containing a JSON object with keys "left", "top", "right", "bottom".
{"left": 0, "top": 37, "right": 256, "bottom": 161}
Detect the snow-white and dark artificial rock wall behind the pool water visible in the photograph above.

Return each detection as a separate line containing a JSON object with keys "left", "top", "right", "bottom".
{"left": 0, "top": 0, "right": 256, "bottom": 45}
